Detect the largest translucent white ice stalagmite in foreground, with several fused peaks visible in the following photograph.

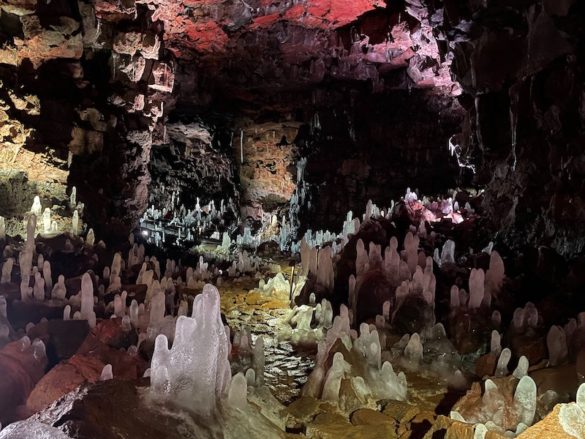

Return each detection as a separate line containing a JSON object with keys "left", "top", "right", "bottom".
{"left": 151, "top": 284, "right": 231, "bottom": 416}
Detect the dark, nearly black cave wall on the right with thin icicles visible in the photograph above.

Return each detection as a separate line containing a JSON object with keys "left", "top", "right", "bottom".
{"left": 424, "top": 0, "right": 585, "bottom": 256}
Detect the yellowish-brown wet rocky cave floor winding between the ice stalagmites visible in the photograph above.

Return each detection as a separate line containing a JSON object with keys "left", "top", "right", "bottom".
{"left": 212, "top": 272, "right": 468, "bottom": 438}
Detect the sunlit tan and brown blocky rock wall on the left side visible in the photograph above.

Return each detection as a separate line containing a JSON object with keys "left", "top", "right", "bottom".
{"left": 0, "top": 0, "right": 173, "bottom": 241}
